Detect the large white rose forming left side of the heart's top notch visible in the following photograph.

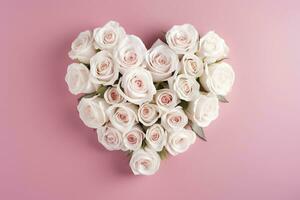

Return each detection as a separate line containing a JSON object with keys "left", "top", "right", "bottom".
{"left": 114, "top": 35, "right": 147, "bottom": 74}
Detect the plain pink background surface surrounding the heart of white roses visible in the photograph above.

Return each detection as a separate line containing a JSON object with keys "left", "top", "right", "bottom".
{"left": 0, "top": 0, "right": 300, "bottom": 200}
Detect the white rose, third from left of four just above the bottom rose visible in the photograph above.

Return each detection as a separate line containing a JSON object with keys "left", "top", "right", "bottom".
{"left": 146, "top": 124, "right": 167, "bottom": 151}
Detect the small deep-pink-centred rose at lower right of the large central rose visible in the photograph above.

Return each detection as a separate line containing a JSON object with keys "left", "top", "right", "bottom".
{"left": 154, "top": 89, "right": 180, "bottom": 112}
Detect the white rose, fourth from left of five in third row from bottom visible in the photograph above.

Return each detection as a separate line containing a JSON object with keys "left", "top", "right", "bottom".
{"left": 161, "top": 106, "right": 188, "bottom": 131}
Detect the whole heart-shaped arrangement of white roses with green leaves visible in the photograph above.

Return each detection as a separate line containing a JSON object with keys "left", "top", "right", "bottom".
{"left": 65, "top": 21, "right": 234, "bottom": 175}
